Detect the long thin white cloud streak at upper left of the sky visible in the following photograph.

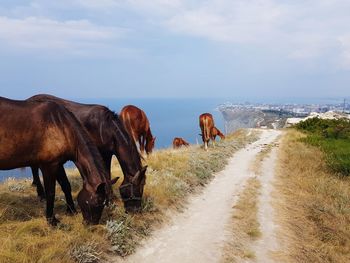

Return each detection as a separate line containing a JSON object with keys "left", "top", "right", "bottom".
{"left": 0, "top": 17, "right": 126, "bottom": 54}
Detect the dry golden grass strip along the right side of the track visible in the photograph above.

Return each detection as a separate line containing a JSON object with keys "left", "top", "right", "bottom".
{"left": 277, "top": 130, "right": 350, "bottom": 262}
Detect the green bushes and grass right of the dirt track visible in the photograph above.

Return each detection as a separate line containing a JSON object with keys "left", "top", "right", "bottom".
{"left": 296, "top": 118, "right": 350, "bottom": 176}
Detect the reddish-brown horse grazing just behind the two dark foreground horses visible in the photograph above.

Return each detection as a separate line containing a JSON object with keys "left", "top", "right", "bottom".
{"left": 120, "top": 105, "right": 156, "bottom": 154}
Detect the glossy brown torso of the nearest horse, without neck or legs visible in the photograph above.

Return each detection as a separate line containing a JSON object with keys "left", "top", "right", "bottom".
{"left": 0, "top": 98, "right": 72, "bottom": 169}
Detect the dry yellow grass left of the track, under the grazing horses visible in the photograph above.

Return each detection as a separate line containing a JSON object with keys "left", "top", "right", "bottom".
{"left": 0, "top": 131, "right": 256, "bottom": 262}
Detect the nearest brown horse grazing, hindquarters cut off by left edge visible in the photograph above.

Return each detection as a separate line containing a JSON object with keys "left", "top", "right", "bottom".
{"left": 0, "top": 97, "right": 115, "bottom": 225}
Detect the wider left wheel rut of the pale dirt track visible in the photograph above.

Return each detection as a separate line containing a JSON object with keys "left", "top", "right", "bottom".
{"left": 115, "top": 130, "right": 280, "bottom": 263}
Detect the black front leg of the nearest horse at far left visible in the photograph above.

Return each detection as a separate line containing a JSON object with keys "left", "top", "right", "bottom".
{"left": 40, "top": 164, "right": 59, "bottom": 226}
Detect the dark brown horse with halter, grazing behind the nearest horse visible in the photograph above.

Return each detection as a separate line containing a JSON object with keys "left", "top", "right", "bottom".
{"left": 28, "top": 95, "right": 147, "bottom": 212}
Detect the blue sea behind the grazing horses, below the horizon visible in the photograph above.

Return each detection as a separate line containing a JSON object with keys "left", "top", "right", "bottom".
{"left": 0, "top": 98, "right": 226, "bottom": 181}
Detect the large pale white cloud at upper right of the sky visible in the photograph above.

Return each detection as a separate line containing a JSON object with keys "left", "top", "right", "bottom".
{"left": 159, "top": 0, "right": 350, "bottom": 66}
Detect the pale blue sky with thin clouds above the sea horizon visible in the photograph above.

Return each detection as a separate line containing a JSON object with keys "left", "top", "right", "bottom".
{"left": 0, "top": 0, "right": 350, "bottom": 100}
